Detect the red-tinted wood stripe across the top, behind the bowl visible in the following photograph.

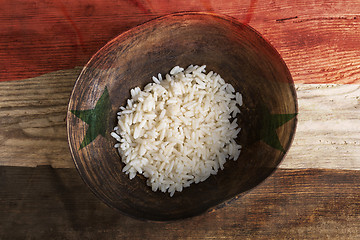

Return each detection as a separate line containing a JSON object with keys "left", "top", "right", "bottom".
{"left": 0, "top": 0, "right": 360, "bottom": 83}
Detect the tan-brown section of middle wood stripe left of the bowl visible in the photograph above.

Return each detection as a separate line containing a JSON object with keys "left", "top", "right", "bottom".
{"left": 0, "top": 68, "right": 82, "bottom": 167}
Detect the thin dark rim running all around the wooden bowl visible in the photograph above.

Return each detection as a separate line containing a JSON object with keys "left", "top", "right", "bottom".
{"left": 66, "top": 11, "right": 298, "bottom": 222}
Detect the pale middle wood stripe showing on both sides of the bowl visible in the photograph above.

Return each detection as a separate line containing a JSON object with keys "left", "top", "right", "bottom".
{"left": 0, "top": 68, "right": 360, "bottom": 170}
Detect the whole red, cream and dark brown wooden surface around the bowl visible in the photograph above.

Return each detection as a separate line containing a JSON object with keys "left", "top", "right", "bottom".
{"left": 0, "top": 0, "right": 360, "bottom": 239}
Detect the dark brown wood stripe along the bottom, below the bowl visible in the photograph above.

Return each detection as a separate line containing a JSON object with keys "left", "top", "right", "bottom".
{"left": 0, "top": 166, "right": 360, "bottom": 239}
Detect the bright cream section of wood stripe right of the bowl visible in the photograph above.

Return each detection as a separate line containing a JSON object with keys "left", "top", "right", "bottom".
{"left": 280, "top": 84, "right": 360, "bottom": 170}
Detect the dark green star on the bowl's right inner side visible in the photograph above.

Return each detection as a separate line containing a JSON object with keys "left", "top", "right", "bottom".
{"left": 260, "top": 106, "right": 297, "bottom": 152}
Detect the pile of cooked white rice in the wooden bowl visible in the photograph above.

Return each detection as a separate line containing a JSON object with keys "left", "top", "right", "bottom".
{"left": 111, "top": 65, "right": 242, "bottom": 196}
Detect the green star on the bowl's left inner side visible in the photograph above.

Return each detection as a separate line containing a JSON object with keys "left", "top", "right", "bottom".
{"left": 70, "top": 87, "right": 110, "bottom": 150}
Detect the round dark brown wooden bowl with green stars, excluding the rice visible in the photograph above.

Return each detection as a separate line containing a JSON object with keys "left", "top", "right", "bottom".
{"left": 67, "top": 12, "right": 297, "bottom": 220}
